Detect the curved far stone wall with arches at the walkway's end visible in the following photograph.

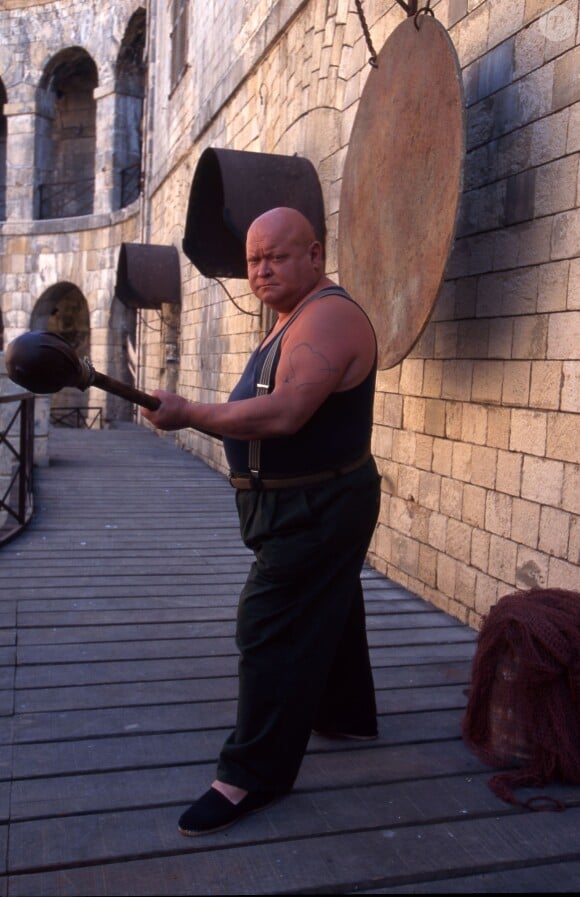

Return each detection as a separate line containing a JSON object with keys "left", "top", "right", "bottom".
{"left": 0, "top": 2, "right": 144, "bottom": 418}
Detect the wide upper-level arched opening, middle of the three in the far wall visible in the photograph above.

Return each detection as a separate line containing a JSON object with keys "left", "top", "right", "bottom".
{"left": 35, "top": 47, "right": 98, "bottom": 218}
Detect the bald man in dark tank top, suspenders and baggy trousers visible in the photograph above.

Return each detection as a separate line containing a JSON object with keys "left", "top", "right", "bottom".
{"left": 143, "top": 208, "right": 380, "bottom": 835}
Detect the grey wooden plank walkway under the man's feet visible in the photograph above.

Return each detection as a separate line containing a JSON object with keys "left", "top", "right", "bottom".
{"left": 0, "top": 425, "right": 580, "bottom": 897}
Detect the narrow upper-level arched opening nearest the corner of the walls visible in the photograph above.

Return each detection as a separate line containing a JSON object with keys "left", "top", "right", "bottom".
{"left": 113, "top": 8, "right": 146, "bottom": 209}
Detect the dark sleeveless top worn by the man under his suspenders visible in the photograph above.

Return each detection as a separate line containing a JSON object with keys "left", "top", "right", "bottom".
{"left": 223, "top": 288, "right": 377, "bottom": 477}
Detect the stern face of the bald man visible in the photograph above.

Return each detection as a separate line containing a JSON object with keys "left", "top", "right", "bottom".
{"left": 246, "top": 216, "right": 320, "bottom": 311}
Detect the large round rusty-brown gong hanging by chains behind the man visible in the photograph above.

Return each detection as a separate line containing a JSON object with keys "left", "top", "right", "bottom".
{"left": 338, "top": 15, "right": 465, "bottom": 370}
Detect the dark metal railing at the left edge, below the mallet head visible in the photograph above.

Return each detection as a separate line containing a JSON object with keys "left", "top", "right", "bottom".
{"left": 0, "top": 393, "right": 34, "bottom": 545}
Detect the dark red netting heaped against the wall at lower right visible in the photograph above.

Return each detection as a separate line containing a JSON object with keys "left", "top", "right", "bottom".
{"left": 462, "top": 589, "right": 580, "bottom": 810}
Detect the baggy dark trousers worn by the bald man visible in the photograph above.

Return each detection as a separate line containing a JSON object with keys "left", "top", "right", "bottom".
{"left": 217, "top": 458, "right": 380, "bottom": 791}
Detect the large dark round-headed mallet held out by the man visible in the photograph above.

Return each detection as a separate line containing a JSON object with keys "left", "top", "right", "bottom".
{"left": 4, "top": 330, "right": 161, "bottom": 411}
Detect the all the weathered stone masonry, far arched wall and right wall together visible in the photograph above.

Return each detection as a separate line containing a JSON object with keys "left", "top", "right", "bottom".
{"left": 0, "top": 0, "right": 580, "bottom": 625}
